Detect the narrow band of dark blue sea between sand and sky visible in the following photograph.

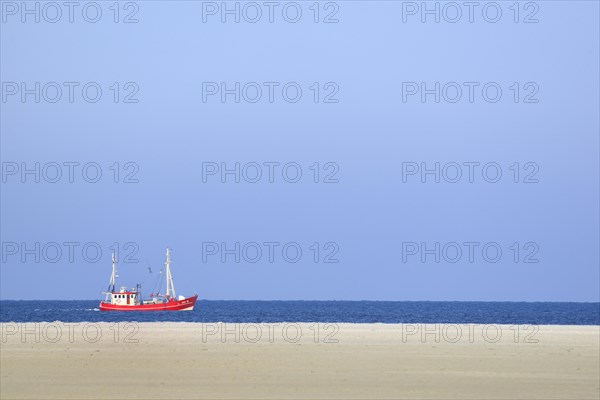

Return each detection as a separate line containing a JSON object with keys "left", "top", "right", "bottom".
{"left": 0, "top": 300, "right": 600, "bottom": 325}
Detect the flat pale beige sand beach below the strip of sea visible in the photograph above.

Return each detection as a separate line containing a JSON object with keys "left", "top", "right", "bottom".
{"left": 0, "top": 322, "right": 600, "bottom": 399}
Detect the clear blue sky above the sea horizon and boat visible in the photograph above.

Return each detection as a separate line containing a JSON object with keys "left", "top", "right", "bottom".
{"left": 0, "top": 1, "right": 600, "bottom": 301}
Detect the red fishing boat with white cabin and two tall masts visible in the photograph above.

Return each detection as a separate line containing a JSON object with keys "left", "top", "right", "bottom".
{"left": 100, "top": 248, "right": 198, "bottom": 311}
